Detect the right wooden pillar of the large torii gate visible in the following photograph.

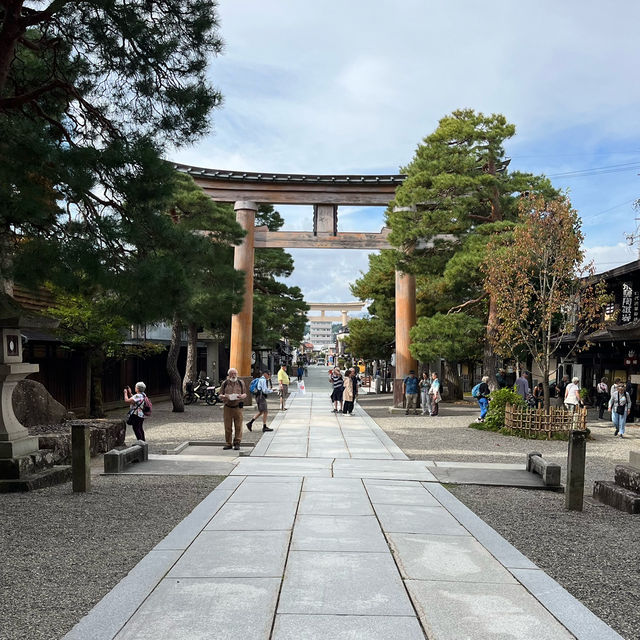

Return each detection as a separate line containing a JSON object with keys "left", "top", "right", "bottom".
{"left": 393, "top": 271, "right": 417, "bottom": 407}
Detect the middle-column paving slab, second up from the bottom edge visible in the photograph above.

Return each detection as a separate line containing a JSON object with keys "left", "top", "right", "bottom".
{"left": 278, "top": 551, "right": 414, "bottom": 616}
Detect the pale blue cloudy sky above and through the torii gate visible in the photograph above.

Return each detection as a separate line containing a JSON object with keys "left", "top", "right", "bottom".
{"left": 169, "top": 0, "right": 640, "bottom": 302}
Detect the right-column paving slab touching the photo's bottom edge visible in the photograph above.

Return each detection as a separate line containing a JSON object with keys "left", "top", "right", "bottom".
{"left": 405, "top": 580, "right": 573, "bottom": 640}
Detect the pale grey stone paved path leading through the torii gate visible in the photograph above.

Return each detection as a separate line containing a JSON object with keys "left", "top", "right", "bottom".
{"left": 65, "top": 370, "right": 620, "bottom": 640}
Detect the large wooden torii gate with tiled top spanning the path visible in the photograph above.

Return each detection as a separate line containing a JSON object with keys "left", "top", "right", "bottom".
{"left": 175, "top": 164, "right": 416, "bottom": 406}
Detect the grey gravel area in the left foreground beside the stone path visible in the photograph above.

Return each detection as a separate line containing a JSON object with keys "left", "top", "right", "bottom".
{"left": 0, "top": 476, "right": 223, "bottom": 640}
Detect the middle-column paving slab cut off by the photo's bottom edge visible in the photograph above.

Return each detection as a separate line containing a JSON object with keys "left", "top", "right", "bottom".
{"left": 272, "top": 613, "right": 424, "bottom": 640}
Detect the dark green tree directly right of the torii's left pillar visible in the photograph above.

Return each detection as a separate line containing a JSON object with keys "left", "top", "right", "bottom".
{"left": 253, "top": 205, "right": 309, "bottom": 348}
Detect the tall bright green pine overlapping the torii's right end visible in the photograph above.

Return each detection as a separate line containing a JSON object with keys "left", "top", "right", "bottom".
{"left": 387, "top": 109, "right": 555, "bottom": 384}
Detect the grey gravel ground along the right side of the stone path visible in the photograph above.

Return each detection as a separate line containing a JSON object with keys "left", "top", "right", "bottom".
{"left": 359, "top": 396, "right": 640, "bottom": 640}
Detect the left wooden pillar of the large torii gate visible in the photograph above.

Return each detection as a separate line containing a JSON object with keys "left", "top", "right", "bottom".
{"left": 229, "top": 200, "right": 258, "bottom": 405}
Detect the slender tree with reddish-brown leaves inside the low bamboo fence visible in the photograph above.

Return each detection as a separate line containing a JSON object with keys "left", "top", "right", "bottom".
{"left": 483, "top": 196, "right": 608, "bottom": 409}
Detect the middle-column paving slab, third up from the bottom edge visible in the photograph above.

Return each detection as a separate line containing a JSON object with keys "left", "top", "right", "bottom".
{"left": 291, "top": 515, "right": 388, "bottom": 553}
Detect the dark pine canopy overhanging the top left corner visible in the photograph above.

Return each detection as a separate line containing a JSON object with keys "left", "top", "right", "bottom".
{"left": 0, "top": 0, "right": 221, "bottom": 291}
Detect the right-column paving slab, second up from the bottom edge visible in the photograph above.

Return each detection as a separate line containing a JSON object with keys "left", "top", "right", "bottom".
{"left": 388, "top": 533, "right": 516, "bottom": 584}
